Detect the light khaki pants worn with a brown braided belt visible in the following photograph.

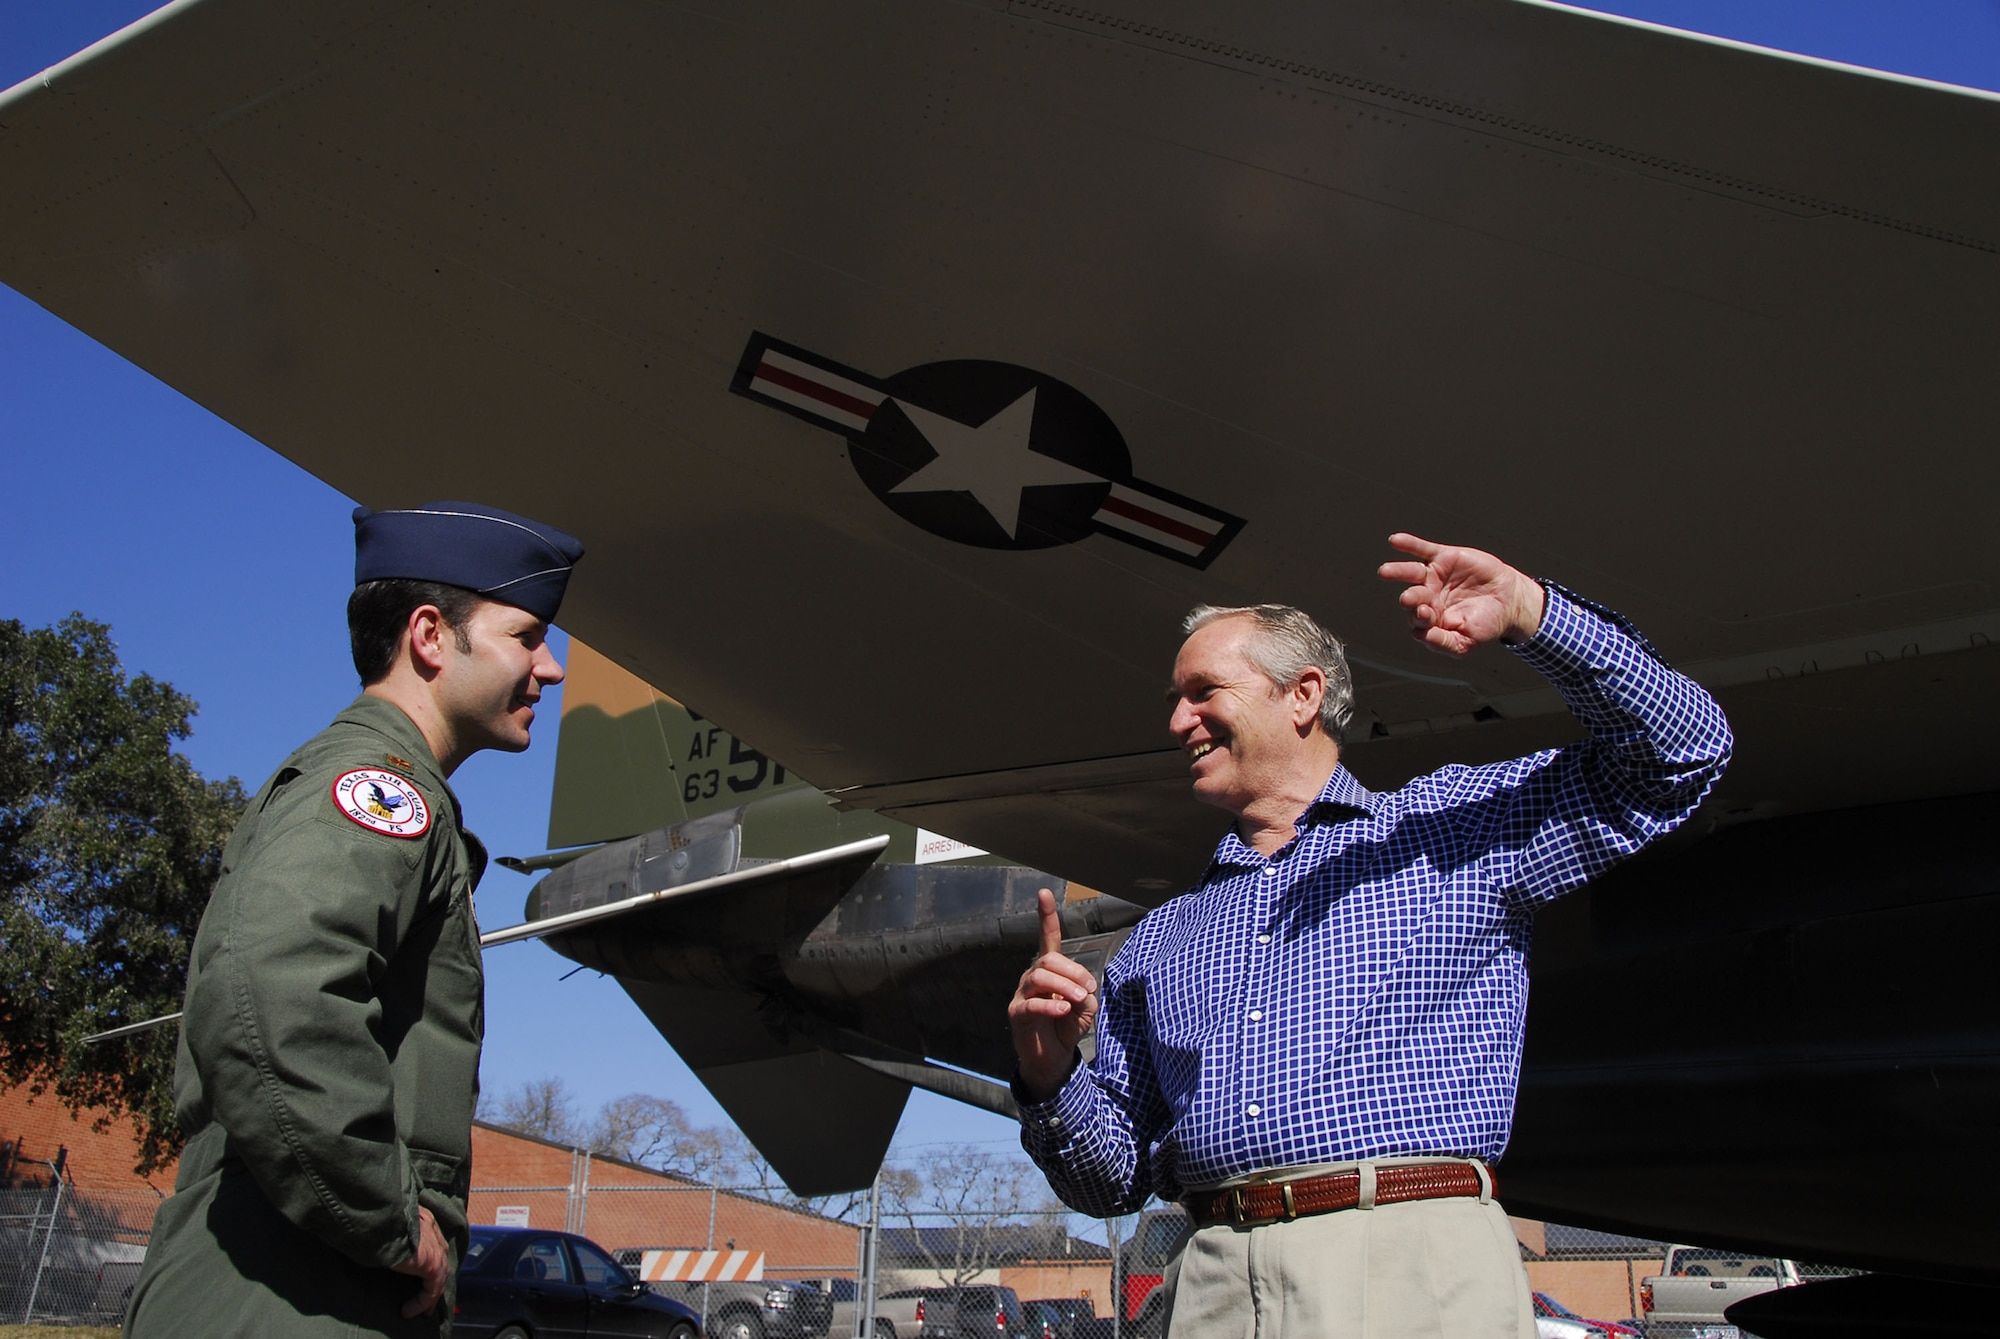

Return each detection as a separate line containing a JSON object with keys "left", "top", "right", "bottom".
{"left": 1164, "top": 1157, "right": 1536, "bottom": 1339}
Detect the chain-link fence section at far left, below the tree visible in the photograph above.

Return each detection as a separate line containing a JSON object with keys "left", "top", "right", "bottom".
{"left": 0, "top": 1181, "right": 160, "bottom": 1325}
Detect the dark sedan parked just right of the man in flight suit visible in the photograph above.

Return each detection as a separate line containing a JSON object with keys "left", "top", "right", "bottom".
{"left": 452, "top": 1227, "right": 700, "bottom": 1339}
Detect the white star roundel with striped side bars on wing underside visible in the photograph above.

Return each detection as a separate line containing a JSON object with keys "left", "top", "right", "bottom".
{"left": 730, "top": 334, "right": 1244, "bottom": 568}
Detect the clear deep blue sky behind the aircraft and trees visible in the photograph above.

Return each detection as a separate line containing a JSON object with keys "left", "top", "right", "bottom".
{"left": 0, "top": 0, "right": 2000, "bottom": 1175}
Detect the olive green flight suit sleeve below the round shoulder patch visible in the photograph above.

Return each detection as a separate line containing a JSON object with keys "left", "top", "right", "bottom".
{"left": 182, "top": 767, "right": 452, "bottom": 1267}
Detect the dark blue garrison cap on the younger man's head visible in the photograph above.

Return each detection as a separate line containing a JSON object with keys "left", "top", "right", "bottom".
{"left": 354, "top": 502, "right": 584, "bottom": 624}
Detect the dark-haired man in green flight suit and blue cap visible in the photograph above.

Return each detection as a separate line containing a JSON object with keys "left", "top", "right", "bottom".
{"left": 126, "top": 502, "right": 584, "bottom": 1339}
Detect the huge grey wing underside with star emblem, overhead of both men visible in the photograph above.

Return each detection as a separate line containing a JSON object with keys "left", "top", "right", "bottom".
{"left": 0, "top": 0, "right": 2000, "bottom": 899}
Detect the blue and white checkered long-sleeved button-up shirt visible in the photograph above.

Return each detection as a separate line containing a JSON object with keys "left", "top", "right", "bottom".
{"left": 1022, "top": 586, "right": 1730, "bottom": 1215}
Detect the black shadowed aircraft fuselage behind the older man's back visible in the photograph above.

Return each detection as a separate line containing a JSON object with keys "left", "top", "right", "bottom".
{"left": 1500, "top": 795, "right": 2000, "bottom": 1287}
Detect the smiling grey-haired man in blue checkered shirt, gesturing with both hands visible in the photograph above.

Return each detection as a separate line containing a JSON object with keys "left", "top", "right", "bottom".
{"left": 1008, "top": 534, "right": 1730, "bottom": 1339}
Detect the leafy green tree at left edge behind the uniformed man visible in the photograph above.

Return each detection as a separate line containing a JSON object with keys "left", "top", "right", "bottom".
{"left": 0, "top": 614, "right": 244, "bottom": 1173}
